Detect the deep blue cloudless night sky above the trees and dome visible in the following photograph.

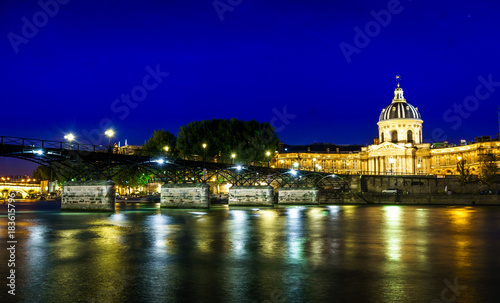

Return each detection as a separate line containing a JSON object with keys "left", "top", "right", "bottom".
{"left": 0, "top": 0, "right": 500, "bottom": 174}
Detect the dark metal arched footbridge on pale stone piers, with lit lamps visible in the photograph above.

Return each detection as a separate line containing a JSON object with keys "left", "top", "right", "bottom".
{"left": 0, "top": 136, "right": 349, "bottom": 211}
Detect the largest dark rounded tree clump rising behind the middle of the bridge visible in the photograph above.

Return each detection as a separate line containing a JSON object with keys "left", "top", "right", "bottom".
{"left": 177, "top": 119, "right": 279, "bottom": 163}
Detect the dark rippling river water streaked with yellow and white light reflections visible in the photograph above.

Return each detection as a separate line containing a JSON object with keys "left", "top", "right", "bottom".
{"left": 0, "top": 203, "right": 500, "bottom": 302}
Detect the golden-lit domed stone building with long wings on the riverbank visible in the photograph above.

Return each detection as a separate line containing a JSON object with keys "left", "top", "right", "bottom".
{"left": 272, "top": 84, "right": 500, "bottom": 175}
